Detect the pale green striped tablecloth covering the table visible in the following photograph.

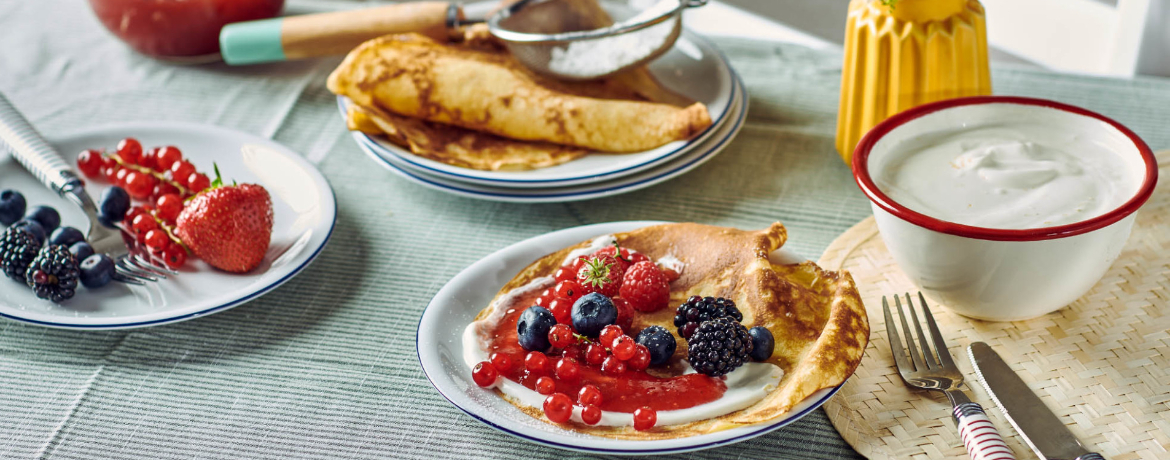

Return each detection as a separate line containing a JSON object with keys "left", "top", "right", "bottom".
{"left": 0, "top": 0, "right": 1170, "bottom": 459}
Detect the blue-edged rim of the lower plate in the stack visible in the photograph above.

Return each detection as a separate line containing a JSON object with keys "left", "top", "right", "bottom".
{"left": 355, "top": 74, "right": 748, "bottom": 202}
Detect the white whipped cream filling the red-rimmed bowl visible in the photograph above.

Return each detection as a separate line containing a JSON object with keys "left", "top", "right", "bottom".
{"left": 872, "top": 122, "right": 1141, "bottom": 229}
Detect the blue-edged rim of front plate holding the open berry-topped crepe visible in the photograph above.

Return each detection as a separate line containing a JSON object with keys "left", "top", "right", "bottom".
{"left": 414, "top": 222, "right": 853, "bottom": 455}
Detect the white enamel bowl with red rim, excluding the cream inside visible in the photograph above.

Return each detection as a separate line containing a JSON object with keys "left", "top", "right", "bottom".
{"left": 853, "top": 96, "right": 1158, "bottom": 321}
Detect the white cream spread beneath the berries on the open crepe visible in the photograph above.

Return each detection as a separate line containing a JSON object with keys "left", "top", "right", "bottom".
{"left": 463, "top": 272, "right": 784, "bottom": 426}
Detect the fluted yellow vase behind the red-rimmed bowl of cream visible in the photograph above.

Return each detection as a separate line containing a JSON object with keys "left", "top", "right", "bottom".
{"left": 837, "top": 0, "right": 991, "bottom": 163}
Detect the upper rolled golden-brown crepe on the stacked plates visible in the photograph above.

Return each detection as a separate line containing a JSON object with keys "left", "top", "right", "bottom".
{"left": 328, "top": 34, "right": 711, "bottom": 152}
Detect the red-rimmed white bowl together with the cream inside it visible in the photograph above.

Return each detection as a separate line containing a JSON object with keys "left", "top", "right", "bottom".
{"left": 853, "top": 96, "right": 1157, "bottom": 321}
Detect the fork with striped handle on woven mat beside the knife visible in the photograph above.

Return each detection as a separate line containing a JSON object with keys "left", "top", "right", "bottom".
{"left": 881, "top": 293, "right": 1016, "bottom": 460}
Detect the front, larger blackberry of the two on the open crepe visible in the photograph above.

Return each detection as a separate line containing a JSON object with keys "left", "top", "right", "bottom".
{"left": 687, "top": 316, "right": 752, "bottom": 377}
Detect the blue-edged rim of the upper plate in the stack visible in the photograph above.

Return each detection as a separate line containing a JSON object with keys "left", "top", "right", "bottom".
{"left": 337, "top": 34, "right": 743, "bottom": 187}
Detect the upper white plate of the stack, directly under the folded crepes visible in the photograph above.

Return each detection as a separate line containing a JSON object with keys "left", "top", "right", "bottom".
{"left": 338, "top": 30, "right": 737, "bottom": 187}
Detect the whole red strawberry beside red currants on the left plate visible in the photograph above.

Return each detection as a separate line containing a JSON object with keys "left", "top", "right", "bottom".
{"left": 176, "top": 167, "right": 273, "bottom": 273}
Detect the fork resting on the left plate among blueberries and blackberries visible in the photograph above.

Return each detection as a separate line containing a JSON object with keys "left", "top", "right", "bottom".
{"left": 0, "top": 94, "right": 178, "bottom": 286}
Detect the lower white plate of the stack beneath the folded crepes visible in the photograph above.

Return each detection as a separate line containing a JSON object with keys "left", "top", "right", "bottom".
{"left": 353, "top": 75, "right": 748, "bottom": 202}
